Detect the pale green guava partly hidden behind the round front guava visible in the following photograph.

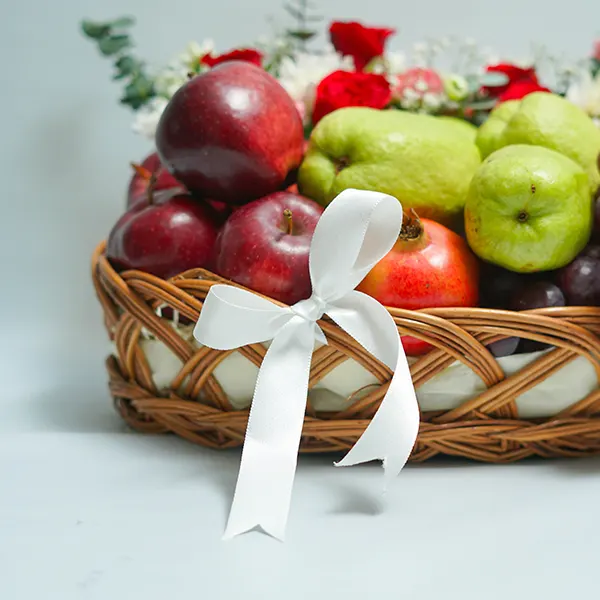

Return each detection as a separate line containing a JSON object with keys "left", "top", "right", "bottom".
{"left": 477, "top": 92, "right": 600, "bottom": 191}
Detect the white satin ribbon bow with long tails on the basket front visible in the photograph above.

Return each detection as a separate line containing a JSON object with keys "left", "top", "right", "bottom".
{"left": 194, "top": 189, "right": 419, "bottom": 540}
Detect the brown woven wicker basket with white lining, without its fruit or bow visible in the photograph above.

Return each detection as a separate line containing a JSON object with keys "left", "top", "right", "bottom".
{"left": 92, "top": 243, "right": 600, "bottom": 463}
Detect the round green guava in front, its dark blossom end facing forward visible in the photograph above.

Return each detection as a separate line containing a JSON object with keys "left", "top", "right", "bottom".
{"left": 465, "top": 144, "right": 593, "bottom": 273}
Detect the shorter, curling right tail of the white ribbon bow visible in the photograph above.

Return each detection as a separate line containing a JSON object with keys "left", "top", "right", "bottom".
{"left": 328, "top": 291, "right": 419, "bottom": 488}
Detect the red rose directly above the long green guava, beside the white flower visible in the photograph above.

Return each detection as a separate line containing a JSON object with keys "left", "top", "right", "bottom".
{"left": 312, "top": 71, "right": 392, "bottom": 125}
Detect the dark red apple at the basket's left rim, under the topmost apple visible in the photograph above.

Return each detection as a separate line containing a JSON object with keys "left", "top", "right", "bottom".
{"left": 106, "top": 190, "right": 218, "bottom": 279}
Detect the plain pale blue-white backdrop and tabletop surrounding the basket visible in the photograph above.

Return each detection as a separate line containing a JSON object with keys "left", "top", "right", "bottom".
{"left": 0, "top": 0, "right": 600, "bottom": 600}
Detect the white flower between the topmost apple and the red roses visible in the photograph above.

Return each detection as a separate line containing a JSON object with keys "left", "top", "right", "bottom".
{"left": 279, "top": 46, "right": 354, "bottom": 124}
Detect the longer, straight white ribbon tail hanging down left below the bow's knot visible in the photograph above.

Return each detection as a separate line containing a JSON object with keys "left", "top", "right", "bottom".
{"left": 224, "top": 317, "right": 315, "bottom": 541}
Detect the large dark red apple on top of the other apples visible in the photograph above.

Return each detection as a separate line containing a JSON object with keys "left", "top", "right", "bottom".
{"left": 156, "top": 61, "right": 304, "bottom": 204}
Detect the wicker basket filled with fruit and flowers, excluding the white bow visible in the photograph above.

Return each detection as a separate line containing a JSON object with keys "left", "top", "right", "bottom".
{"left": 82, "top": 2, "right": 600, "bottom": 460}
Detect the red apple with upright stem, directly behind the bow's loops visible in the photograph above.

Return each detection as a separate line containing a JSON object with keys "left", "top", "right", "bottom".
{"left": 214, "top": 191, "right": 323, "bottom": 304}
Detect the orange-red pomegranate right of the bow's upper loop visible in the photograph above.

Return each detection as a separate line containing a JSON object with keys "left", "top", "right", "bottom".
{"left": 357, "top": 219, "right": 479, "bottom": 356}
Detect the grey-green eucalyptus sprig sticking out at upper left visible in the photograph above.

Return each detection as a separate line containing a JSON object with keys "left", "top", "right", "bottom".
{"left": 81, "top": 16, "right": 156, "bottom": 110}
